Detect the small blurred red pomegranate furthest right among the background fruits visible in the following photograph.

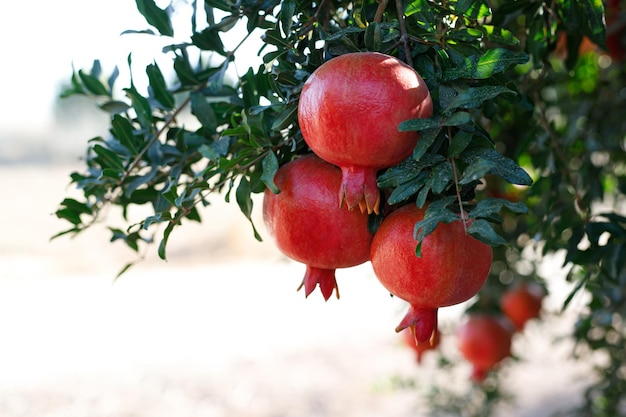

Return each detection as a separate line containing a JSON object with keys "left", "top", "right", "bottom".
{"left": 500, "top": 284, "right": 544, "bottom": 331}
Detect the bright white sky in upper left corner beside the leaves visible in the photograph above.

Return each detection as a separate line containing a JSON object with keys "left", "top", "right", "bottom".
{"left": 0, "top": 0, "right": 264, "bottom": 135}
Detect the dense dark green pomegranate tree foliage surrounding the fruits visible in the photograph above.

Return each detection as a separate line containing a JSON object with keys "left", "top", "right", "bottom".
{"left": 56, "top": 0, "right": 626, "bottom": 416}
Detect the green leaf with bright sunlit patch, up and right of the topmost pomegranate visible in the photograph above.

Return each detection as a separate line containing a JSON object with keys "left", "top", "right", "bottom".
{"left": 443, "top": 48, "right": 528, "bottom": 81}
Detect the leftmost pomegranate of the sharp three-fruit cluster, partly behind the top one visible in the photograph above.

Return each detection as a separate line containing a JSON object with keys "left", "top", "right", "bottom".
{"left": 263, "top": 155, "right": 372, "bottom": 300}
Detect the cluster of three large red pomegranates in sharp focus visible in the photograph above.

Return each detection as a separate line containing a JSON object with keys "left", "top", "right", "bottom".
{"left": 263, "top": 52, "right": 492, "bottom": 343}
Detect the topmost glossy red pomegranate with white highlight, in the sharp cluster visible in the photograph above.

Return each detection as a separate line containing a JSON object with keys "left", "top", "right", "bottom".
{"left": 298, "top": 52, "right": 433, "bottom": 213}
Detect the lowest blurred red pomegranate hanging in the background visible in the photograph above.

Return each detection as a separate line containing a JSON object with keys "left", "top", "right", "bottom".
{"left": 457, "top": 314, "right": 512, "bottom": 381}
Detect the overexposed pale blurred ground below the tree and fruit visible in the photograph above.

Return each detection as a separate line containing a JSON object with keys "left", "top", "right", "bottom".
{"left": 0, "top": 165, "right": 589, "bottom": 417}
